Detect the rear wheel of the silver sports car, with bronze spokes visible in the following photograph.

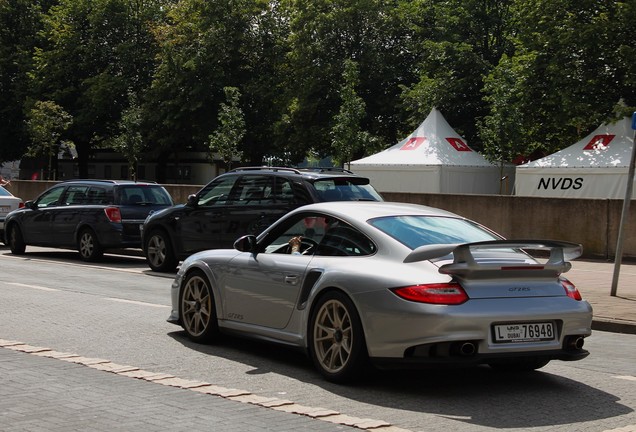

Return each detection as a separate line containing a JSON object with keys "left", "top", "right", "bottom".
{"left": 308, "top": 291, "right": 368, "bottom": 383}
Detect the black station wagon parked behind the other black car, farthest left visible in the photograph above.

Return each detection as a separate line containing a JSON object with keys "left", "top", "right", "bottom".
{"left": 5, "top": 180, "right": 174, "bottom": 261}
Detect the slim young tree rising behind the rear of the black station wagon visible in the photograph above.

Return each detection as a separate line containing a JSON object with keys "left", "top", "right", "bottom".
{"left": 110, "top": 91, "right": 144, "bottom": 180}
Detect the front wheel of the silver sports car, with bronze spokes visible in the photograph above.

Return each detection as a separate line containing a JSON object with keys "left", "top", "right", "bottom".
{"left": 179, "top": 270, "right": 219, "bottom": 343}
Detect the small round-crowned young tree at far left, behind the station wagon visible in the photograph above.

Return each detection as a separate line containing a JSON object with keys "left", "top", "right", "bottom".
{"left": 27, "top": 101, "right": 73, "bottom": 180}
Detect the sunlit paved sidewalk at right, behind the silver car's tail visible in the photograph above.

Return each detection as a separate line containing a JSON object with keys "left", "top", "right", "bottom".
{"left": 565, "top": 260, "right": 636, "bottom": 334}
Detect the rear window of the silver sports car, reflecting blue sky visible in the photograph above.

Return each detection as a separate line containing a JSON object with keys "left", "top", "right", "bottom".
{"left": 369, "top": 216, "right": 500, "bottom": 249}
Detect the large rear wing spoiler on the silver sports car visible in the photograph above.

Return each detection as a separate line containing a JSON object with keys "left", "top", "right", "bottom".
{"left": 404, "top": 240, "right": 583, "bottom": 277}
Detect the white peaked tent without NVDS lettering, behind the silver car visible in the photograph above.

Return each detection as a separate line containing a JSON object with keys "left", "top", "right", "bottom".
{"left": 351, "top": 108, "right": 506, "bottom": 194}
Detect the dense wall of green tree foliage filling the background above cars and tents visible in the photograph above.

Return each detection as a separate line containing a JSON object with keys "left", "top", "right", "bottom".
{"left": 0, "top": 0, "right": 636, "bottom": 176}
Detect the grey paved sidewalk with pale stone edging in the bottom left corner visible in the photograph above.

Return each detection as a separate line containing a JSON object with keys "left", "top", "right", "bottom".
{"left": 0, "top": 341, "right": 362, "bottom": 432}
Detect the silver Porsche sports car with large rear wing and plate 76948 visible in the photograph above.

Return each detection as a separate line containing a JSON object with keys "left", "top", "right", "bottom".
{"left": 168, "top": 202, "right": 592, "bottom": 382}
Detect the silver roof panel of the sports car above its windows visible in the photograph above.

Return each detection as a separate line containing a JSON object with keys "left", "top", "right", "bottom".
{"left": 288, "top": 201, "right": 464, "bottom": 221}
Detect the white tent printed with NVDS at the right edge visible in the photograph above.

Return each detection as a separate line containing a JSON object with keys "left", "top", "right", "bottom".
{"left": 515, "top": 117, "right": 636, "bottom": 199}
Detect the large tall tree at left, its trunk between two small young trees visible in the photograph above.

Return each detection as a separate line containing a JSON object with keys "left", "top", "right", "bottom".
{"left": 33, "top": 0, "right": 169, "bottom": 177}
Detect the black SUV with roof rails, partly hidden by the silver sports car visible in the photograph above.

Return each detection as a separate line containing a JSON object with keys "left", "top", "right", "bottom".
{"left": 143, "top": 167, "right": 382, "bottom": 272}
